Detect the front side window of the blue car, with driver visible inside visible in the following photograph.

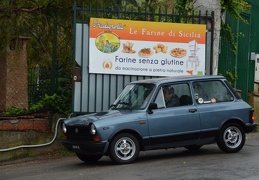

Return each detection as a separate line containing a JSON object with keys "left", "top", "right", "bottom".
{"left": 156, "top": 83, "right": 192, "bottom": 108}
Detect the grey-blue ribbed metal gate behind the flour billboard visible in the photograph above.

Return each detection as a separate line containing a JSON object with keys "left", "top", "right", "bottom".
{"left": 72, "top": 1, "right": 214, "bottom": 114}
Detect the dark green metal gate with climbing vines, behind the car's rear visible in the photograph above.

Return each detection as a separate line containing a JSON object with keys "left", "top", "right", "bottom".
{"left": 218, "top": 10, "right": 254, "bottom": 100}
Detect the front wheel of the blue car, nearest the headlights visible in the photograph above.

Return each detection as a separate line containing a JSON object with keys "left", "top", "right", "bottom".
{"left": 109, "top": 133, "right": 139, "bottom": 164}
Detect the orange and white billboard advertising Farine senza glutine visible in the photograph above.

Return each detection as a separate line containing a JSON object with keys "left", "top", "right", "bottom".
{"left": 89, "top": 18, "right": 206, "bottom": 76}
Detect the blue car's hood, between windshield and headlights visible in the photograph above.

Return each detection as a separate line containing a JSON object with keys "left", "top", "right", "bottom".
{"left": 64, "top": 110, "right": 135, "bottom": 125}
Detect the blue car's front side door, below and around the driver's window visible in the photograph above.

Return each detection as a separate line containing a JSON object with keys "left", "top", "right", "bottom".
{"left": 147, "top": 83, "right": 201, "bottom": 148}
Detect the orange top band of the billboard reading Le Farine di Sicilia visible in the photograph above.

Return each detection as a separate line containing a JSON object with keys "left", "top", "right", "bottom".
{"left": 90, "top": 18, "right": 206, "bottom": 44}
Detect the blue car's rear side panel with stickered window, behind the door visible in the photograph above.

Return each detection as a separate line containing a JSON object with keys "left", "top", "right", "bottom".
{"left": 192, "top": 80, "right": 237, "bottom": 143}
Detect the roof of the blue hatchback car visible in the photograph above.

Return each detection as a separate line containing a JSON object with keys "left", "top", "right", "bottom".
{"left": 131, "top": 75, "right": 225, "bottom": 84}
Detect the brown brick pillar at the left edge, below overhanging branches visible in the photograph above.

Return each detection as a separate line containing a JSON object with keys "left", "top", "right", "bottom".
{"left": 0, "top": 37, "right": 28, "bottom": 112}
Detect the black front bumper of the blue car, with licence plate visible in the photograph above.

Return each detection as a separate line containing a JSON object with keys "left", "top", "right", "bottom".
{"left": 62, "top": 141, "right": 106, "bottom": 155}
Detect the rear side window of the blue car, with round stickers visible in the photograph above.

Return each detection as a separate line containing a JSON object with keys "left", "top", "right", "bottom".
{"left": 193, "top": 81, "right": 234, "bottom": 104}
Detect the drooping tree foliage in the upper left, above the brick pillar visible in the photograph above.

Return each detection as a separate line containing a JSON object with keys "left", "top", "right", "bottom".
{"left": 0, "top": 0, "right": 73, "bottom": 69}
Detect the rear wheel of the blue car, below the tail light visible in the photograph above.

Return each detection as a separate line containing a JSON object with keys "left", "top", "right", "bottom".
{"left": 217, "top": 123, "right": 246, "bottom": 153}
